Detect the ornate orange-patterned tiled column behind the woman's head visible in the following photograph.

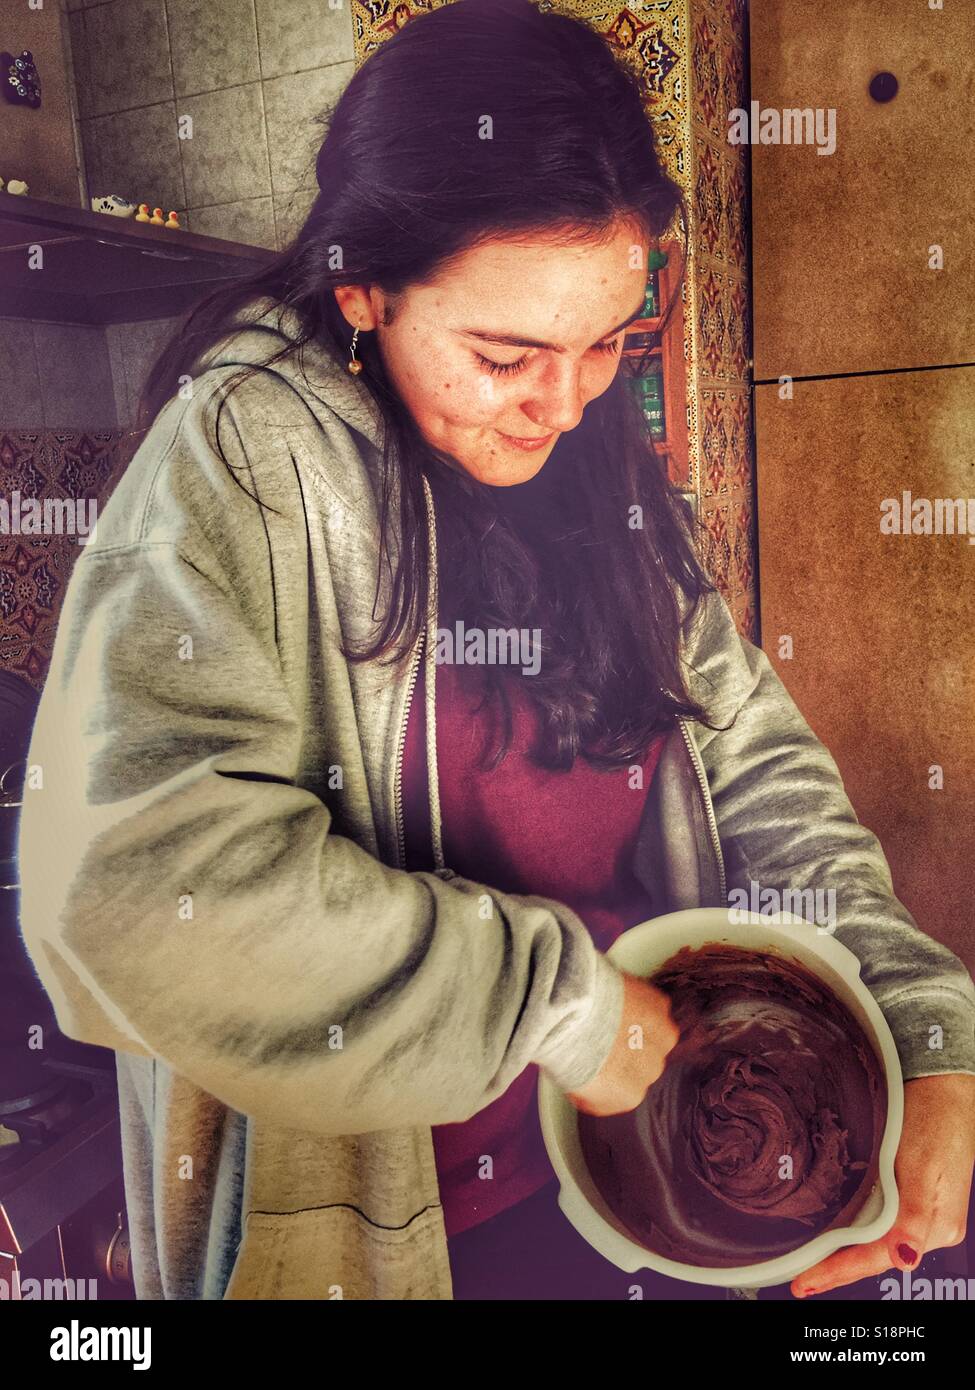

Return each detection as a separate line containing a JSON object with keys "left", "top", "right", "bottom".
{"left": 347, "top": 0, "right": 758, "bottom": 639}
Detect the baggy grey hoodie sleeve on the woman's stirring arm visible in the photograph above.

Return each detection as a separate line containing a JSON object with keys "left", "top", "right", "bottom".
{"left": 18, "top": 405, "right": 623, "bottom": 1134}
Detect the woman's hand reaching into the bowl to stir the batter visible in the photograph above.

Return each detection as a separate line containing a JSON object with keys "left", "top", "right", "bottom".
{"left": 566, "top": 972, "right": 675, "bottom": 1115}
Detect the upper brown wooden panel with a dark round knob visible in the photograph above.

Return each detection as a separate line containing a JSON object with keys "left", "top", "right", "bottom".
{"left": 750, "top": 0, "right": 975, "bottom": 381}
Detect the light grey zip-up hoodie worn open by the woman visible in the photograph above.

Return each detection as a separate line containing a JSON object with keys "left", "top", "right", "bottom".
{"left": 19, "top": 302, "right": 975, "bottom": 1298}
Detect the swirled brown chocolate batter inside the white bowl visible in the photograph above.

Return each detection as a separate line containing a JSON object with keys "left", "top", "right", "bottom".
{"left": 579, "top": 944, "right": 887, "bottom": 1268}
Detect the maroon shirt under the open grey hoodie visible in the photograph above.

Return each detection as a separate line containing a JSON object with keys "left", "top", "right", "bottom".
{"left": 403, "top": 663, "right": 663, "bottom": 1237}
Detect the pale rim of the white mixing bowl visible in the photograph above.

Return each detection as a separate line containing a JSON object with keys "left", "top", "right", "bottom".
{"left": 538, "top": 908, "right": 904, "bottom": 1289}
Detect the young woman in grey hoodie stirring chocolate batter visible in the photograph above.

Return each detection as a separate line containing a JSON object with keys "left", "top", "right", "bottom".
{"left": 21, "top": 0, "right": 975, "bottom": 1298}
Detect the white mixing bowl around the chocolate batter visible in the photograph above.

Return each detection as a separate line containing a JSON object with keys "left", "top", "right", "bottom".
{"left": 538, "top": 908, "right": 904, "bottom": 1289}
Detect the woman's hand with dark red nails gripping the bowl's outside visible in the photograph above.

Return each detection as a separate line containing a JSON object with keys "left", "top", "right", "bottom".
{"left": 790, "top": 1072, "right": 975, "bottom": 1298}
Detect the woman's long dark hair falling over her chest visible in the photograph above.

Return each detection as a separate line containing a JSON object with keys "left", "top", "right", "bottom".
{"left": 139, "top": 0, "right": 716, "bottom": 769}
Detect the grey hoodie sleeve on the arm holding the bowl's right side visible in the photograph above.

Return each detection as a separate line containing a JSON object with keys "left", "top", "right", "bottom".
{"left": 684, "top": 595, "right": 975, "bottom": 1080}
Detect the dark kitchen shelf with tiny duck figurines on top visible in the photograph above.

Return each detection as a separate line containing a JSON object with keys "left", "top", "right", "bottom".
{"left": 0, "top": 192, "right": 275, "bottom": 324}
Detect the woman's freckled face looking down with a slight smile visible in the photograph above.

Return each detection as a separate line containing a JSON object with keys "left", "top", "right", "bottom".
{"left": 337, "top": 224, "right": 650, "bottom": 487}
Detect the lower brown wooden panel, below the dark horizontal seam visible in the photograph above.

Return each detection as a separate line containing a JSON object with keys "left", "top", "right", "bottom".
{"left": 755, "top": 368, "right": 975, "bottom": 967}
